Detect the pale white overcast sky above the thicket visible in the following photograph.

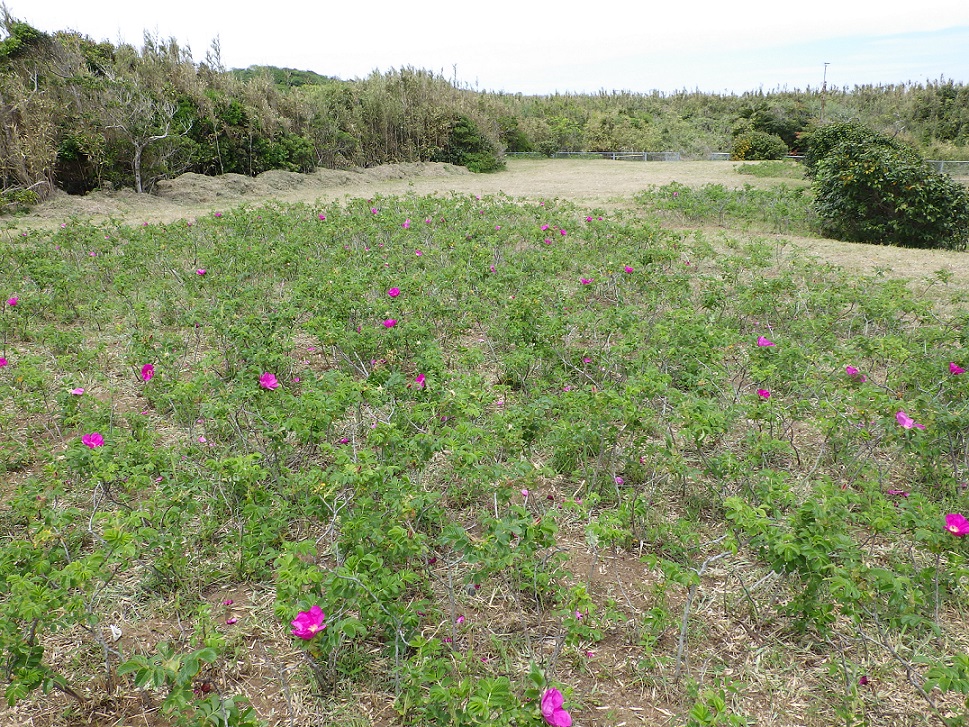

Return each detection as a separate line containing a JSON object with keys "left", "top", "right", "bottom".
{"left": 6, "top": 0, "right": 969, "bottom": 94}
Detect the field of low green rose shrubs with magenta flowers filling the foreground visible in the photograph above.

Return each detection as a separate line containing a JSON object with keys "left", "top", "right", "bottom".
{"left": 0, "top": 191, "right": 969, "bottom": 726}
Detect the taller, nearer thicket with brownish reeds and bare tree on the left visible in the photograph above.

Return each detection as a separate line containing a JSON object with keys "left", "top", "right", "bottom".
{"left": 0, "top": 16, "right": 502, "bottom": 206}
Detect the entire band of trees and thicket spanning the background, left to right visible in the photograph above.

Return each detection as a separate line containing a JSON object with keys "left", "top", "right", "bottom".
{"left": 0, "top": 11, "right": 969, "bottom": 208}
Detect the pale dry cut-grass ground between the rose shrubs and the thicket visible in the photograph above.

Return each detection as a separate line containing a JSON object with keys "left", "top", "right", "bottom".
{"left": 14, "top": 159, "right": 969, "bottom": 289}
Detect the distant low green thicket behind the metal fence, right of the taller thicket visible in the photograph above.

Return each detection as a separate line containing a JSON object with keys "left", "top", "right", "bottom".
{"left": 491, "top": 79, "right": 969, "bottom": 159}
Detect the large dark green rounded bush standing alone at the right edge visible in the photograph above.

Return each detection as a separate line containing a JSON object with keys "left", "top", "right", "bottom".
{"left": 811, "top": 124, "right": 969, "bottom": 250}
